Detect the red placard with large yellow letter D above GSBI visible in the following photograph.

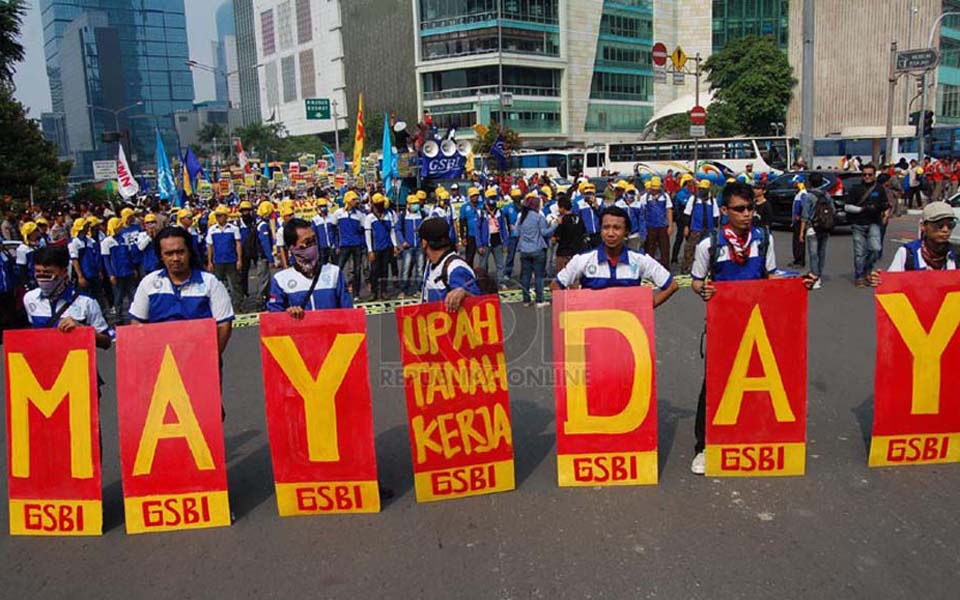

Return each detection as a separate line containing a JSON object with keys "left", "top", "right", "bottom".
{"left": 553, "top": 287, "right": 657, "bottom": 487}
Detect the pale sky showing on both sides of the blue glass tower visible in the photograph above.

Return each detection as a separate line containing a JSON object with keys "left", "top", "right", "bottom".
{"left": 14, "top": 0, "right": 221, "bottom": 119}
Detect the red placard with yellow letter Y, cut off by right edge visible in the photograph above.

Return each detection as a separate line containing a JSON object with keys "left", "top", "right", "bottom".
{"left": 870, "top": 271, "right": 960, "bottom": 467}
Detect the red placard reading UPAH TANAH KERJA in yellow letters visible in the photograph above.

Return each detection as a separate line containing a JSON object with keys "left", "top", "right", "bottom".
{"left": 397, "top": 296, "right": 514, "bottom": 502}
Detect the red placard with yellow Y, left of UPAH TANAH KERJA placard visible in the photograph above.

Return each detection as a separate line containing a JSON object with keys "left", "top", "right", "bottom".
{"left": 260, "top": 308, "right": 380, "bottom": 517}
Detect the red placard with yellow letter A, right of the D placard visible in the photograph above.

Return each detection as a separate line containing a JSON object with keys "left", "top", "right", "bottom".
{"left": 706, "top": 279, "right": 807, "bottom": 476}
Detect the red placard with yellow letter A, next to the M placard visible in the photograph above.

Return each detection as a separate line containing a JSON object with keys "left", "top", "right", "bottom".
{"left": 117, "top": 319, "right": 230, "bottom": 533}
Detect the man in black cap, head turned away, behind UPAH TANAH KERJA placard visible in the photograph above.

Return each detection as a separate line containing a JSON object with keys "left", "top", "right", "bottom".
{"left": 420, "top": 218, "right": 480, "bottom": 312}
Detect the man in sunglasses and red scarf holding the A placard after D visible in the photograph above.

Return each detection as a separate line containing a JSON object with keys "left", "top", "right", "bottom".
{"left": 690, "top": 182, "right": 817, "bottom": 475}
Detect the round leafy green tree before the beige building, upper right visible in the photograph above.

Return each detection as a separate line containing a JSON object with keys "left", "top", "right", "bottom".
{"left": 704, "top": 36, "right": 797, "bottom": 135}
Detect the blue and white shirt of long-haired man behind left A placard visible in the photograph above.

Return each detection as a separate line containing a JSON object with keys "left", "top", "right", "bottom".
{"left": 130, "top": 269, "right": 233, "bottom": 323}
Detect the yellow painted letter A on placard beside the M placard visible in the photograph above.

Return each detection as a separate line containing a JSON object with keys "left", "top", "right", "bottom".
{"left": 133, "top": 346, "right": 214, "bottom": 475}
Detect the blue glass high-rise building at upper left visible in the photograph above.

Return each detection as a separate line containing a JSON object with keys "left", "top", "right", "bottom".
{"left": 40, "top": 0, "right": 194, "bottom": 178}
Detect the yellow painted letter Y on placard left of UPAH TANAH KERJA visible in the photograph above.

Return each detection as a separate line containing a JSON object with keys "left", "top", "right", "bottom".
{"left": 263, "top": 333, "right": 365, "bottom": 462}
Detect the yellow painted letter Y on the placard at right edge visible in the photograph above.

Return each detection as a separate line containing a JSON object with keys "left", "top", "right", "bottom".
{"left": 877, "top": 292, "right": 960, "bottom": 415}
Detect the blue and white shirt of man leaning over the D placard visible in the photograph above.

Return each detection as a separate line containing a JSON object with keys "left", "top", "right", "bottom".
{"left": 557, "top": 246, "right": 673, "bottom": 290}
